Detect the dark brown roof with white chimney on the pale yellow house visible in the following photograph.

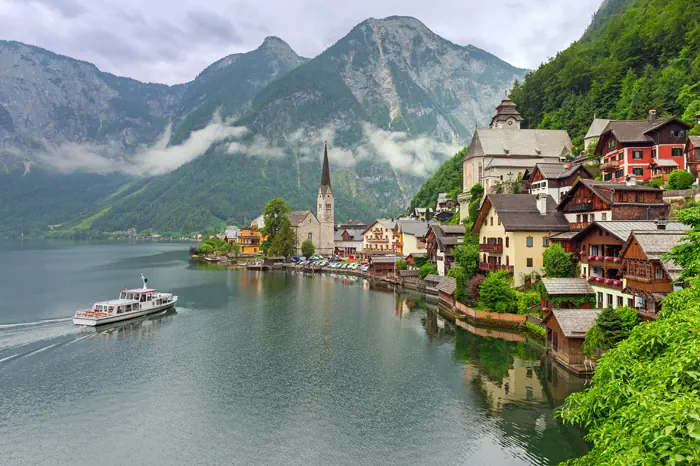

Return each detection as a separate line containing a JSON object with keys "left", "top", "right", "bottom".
{"left": 472, "top": 194, "right": 570, "bottom": 232}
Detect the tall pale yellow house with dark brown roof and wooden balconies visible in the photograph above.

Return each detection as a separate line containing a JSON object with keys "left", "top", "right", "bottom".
{"left": 472, "top": 194, "right": 569, "bottom": 286}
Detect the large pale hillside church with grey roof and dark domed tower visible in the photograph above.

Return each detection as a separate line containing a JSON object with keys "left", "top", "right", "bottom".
{"left": 459, "top": 98, "right": 572, "bottom": 211}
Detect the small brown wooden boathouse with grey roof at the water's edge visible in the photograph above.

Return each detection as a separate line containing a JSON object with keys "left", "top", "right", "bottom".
{"left": 542, "top": 309, "right": 601, "bottom": 373}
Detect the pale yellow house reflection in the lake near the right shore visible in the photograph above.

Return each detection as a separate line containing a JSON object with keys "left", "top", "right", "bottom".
{"left": 464, "top": 357, "right": 547, "bottom": 411}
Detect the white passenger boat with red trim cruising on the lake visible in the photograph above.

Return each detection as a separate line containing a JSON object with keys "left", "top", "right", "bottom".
{"left": 73, "top": 274, "right": 177, "bottom": 327}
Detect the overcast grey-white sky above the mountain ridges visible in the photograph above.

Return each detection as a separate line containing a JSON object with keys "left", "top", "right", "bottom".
{"left": 0, "top": 0, "right": 601, "bottom": 84}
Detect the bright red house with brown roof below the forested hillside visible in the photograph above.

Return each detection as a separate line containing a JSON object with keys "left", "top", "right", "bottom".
{"left": 595, "top": 110, "right": 691, "bottom": 181}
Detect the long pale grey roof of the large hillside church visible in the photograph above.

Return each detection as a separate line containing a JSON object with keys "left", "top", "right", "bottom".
{"left": 466, "top": 128, "right": 572, "bottom": 160}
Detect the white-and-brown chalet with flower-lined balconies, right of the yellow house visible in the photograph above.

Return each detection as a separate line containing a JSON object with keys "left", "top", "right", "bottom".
{"left": 572, "top": 220, "right": 688, "bottom": 308}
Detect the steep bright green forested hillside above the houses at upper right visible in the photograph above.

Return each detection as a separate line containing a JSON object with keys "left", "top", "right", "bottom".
{"left": 511, "top": 0, "right": 700, "bottom": 149}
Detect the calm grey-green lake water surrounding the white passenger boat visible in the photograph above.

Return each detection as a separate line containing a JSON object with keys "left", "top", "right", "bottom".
{"left": 0, "top": 241, "right": 587, "bottom": 466}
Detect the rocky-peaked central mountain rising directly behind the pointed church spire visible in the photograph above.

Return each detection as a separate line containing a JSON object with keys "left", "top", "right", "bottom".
{"left": 90, "top": 17, "right": 524, "bottom": 235}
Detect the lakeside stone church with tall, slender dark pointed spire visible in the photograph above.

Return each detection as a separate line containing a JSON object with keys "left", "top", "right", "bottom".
{"left": 288, "top": 144, "right": 335, "bottom": 256}
